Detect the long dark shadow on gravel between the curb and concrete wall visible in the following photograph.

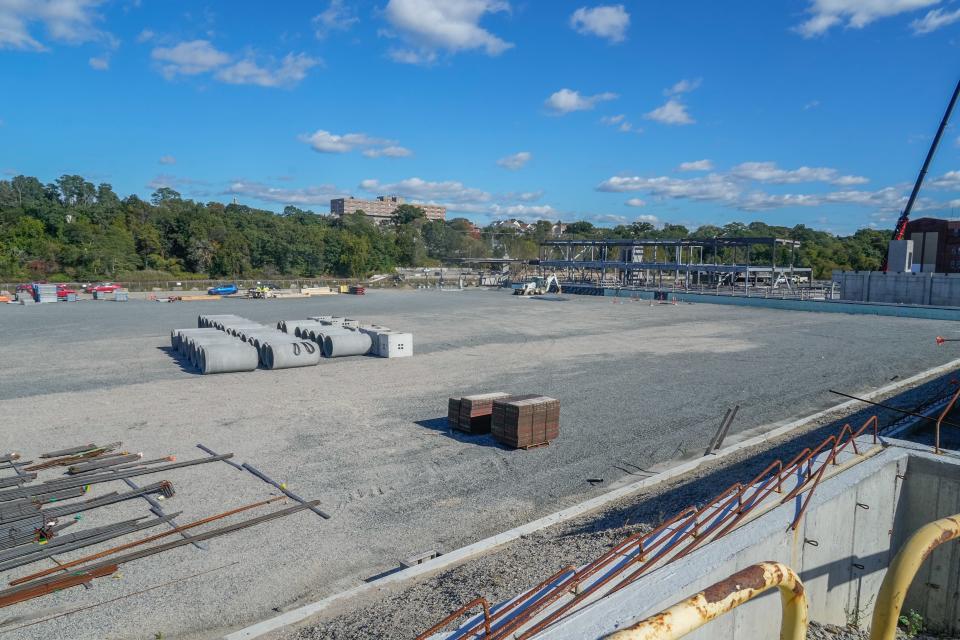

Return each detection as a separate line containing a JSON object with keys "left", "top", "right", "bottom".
{"left": 561, "top": 373, "right": 956, "bottom": 537}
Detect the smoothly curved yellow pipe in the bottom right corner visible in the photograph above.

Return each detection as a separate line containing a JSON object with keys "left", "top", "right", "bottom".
{"left": 870, "top": 514, "right": 960, "bottom": 640}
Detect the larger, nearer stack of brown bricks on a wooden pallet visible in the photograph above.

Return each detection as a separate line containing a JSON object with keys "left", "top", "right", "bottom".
{"left": 491, "top": 395, "right": 560, "bottom": 449}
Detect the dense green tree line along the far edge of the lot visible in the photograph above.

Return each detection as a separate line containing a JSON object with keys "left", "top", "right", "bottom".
{"left": 0, "top": 175, "right": 891, "bottom": 281}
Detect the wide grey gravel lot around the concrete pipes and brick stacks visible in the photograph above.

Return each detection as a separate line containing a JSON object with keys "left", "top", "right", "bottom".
{"left": 0, "top": 290, "right": 956, "bottom": 639}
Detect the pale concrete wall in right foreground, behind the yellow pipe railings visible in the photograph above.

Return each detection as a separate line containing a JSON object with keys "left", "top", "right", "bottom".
{"left": 543, "top": 447, "right": 932, "bottom": 640}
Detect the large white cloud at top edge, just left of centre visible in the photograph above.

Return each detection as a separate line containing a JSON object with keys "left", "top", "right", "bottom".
{"left": 384, "top": 0, "right": 513, "bottom": 64}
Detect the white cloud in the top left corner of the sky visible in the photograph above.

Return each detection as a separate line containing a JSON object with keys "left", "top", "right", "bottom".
{"left": 0, "top": 0, "right": 117, "bottom": 51}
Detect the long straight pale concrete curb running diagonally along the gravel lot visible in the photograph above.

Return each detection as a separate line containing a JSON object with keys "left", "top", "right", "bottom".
{"left": 224, "top": 359, "right": 960, "bottom": 640}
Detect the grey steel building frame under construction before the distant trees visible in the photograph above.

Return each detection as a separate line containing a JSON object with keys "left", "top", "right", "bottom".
{"left": 540, "top": 237, "right": 813, "bottom": 295}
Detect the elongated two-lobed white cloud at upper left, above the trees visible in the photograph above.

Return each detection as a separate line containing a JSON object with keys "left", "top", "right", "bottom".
{"left": 150, "top": 40, "right": 320, "bottom": 87}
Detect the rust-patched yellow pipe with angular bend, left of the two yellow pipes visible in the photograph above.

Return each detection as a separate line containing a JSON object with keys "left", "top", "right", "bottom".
{"left": 606, "top": 562, "right": 807, "bottom": 640}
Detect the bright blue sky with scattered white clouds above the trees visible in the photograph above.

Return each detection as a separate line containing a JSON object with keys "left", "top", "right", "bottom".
{"left": 0, "top": 0, "right": 960, "bottom": 233}
